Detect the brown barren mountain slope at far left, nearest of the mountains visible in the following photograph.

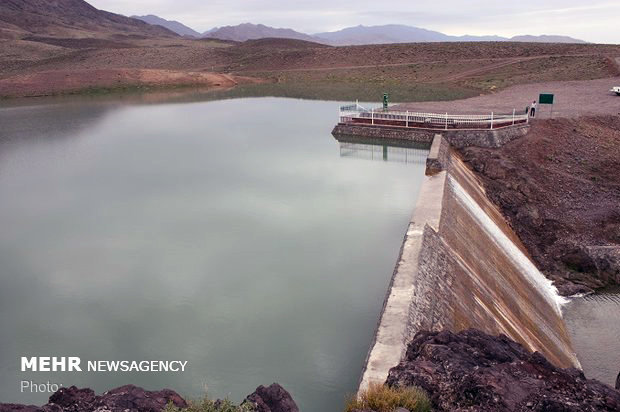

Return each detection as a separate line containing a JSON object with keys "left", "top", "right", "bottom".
{"left": 0, "top": 0, "right": 177, "bottom": 38}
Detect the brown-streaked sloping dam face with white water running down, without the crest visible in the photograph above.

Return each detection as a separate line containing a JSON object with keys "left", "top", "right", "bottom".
{"left": 410, "top": 156, "right": 579, "bottom": 367}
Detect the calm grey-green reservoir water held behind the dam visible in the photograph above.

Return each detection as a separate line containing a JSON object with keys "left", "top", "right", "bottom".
{"left": 0, "top": 98, "right": 425, "bottom": 412}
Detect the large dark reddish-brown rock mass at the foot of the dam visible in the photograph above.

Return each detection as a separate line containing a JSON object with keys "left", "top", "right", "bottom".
{"left": 387, "top": 329, "right": 620, "bottom": 412}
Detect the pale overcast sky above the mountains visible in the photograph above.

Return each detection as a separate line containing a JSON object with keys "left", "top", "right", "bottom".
{"left": 87, "top": 0, "right": 620, "bottom": 43}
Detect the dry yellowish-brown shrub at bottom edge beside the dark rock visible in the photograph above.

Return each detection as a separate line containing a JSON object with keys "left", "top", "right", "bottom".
{"left": 345, "top": 384, "right": 431, "bottom": 412}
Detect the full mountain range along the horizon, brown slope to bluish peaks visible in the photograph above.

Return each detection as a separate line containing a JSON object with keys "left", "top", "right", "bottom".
{"left": 0, "top": 0, "right": 585, "bottom": 46}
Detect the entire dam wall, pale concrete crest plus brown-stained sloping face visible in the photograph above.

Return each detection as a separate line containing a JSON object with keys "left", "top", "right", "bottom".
{"left": 360, "top": 138, "right": 579, "bottom": 390}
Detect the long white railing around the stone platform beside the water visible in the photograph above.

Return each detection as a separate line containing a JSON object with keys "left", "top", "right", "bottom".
{"left": 339, "top": 103, "right": 529, "bottom": 130}
